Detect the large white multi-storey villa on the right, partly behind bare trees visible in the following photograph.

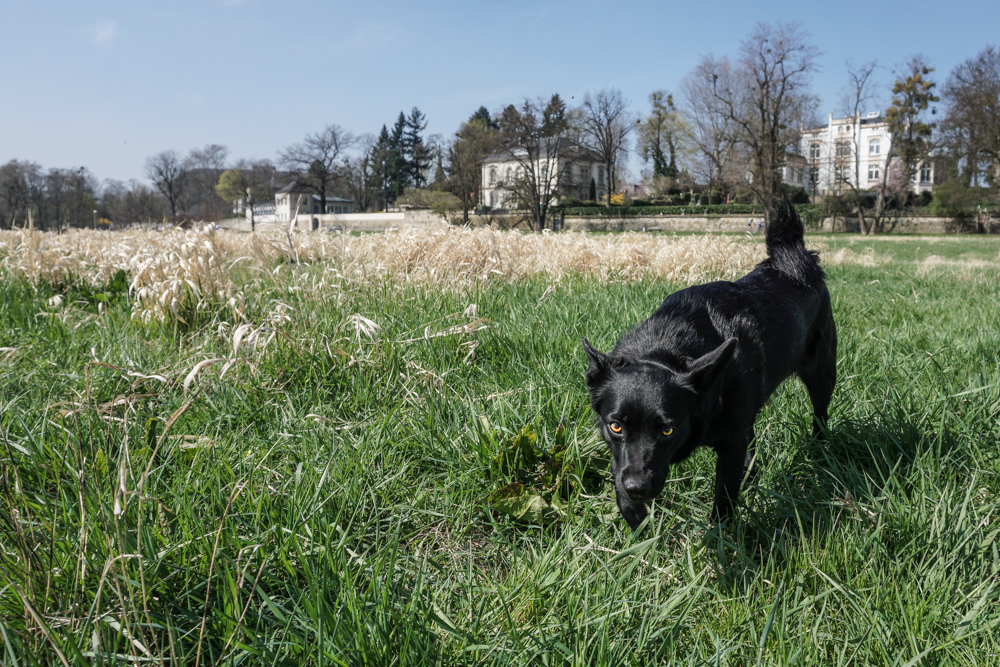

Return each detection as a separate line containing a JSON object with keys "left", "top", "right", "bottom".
{"left": 799, "top": 111, "right": 935, "bottom": 196}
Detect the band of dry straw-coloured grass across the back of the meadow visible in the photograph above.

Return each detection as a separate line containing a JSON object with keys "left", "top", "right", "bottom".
{"left": 0, "top": 227, "right": 968, "bottom": 321}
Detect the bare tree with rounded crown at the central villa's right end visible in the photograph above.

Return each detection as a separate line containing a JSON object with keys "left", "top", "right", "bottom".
{"left": 576, "top": 88, "right": 636, "bottom": 205}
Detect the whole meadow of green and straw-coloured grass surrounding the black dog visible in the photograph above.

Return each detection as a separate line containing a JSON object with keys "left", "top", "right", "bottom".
{"left": 0, "top": 228, "right": 1000, "bottom": 666}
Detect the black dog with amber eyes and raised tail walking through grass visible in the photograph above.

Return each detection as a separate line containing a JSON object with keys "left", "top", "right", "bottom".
{"left": 583, "top": 201, "right": 837, "bottom": 529}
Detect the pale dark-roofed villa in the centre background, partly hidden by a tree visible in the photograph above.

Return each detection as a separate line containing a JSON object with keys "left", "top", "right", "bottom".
{"left": 479, "top": 146, "right": 608, "bottom": 209}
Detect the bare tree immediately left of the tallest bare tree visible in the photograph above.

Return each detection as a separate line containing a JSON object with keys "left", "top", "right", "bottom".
{"left": 680, "top": 56, "right": 743, "bottom": 190}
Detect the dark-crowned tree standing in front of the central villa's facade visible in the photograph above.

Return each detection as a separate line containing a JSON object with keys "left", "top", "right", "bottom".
{"left": 497, "top": 95, "right": 572, "bottom": 230}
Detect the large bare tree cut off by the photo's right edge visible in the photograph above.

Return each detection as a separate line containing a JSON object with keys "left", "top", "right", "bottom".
{"left": 935, "top": 46, "right": 1000, "bottom": 198}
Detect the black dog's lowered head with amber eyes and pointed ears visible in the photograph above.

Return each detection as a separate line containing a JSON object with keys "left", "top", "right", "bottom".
{"left": 583, "top": 338, "right": 736, "bottom": 502}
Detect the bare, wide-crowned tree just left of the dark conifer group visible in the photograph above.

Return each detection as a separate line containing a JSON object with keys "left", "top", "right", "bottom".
{"left": 280, "top": 125, "right": 355, "bottom": 213}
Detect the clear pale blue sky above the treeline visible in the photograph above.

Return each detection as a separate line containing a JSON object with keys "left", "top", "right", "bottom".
{"left": 0, "top": 0, "right": 1000, "bottom": 180}
